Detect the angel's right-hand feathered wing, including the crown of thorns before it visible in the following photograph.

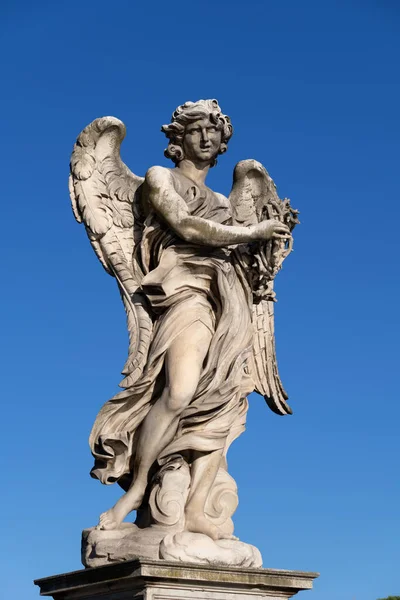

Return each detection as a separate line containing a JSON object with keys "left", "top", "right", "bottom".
{"left": 229, "top": 160, "right": 298, "bottom": 415}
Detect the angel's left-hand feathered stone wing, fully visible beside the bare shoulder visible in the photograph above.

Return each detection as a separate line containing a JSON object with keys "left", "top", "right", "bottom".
{"left": 69, "top": 117, "right": 152, "bottom": 388}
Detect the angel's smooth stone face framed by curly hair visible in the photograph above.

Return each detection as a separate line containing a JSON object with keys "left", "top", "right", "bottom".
{"left": 183, "top": 118, "right": 222, "bottom": 163}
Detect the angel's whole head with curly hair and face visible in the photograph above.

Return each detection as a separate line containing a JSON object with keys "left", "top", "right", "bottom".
{"left": 161, "top": 100, "right": 233, "bottom": 167}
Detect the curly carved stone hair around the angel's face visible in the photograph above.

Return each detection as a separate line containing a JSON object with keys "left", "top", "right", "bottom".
{"left": 161, "top": 100, "right": 233, "bottom": 167}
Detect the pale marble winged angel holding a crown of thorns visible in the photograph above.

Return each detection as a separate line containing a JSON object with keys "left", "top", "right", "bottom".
{"left": 70, "top": 100, "right": 298, "bottom": 568}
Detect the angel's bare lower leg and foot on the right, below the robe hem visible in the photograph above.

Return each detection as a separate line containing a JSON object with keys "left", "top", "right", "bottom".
{"left": 185, "top": 450, "right": 233, "bottom": 540}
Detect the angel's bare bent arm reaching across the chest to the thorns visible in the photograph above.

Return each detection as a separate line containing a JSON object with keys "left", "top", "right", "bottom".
{"left": 146, "top": 167, "right": 283, "bottom": 247}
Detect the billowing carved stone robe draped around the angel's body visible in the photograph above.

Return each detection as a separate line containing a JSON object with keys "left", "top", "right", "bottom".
{"left": 89, "top": 171, "right": 252, "bottom": 483}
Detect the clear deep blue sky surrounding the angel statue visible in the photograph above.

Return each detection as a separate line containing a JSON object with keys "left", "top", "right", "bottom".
{"left": 0, "top": 0, "right": 400, "bottom": 600}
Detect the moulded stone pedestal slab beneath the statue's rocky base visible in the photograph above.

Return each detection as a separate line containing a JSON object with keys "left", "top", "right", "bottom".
{"left": 35, "top": 559, "right": 318, "bottom": 600}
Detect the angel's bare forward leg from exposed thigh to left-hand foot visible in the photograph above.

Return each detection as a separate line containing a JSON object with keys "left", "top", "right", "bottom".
{"left": 99, "top": 321, "right": 212, "bottom": 529}
